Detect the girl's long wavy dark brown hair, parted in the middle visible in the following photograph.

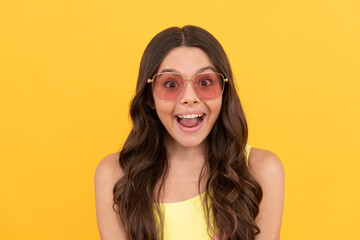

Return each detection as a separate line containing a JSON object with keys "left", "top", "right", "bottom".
{"left": 113, "top": 25, "right": 262, "bottom": 240}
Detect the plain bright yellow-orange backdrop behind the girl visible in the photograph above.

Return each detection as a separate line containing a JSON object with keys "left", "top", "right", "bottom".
{"left": 0, "top": 0, "right": 360, "bottom": 240}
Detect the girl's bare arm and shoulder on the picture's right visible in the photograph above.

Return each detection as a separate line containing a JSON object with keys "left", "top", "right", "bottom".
{"left": 249, "top": 148, "right": 284, "bottom": 240}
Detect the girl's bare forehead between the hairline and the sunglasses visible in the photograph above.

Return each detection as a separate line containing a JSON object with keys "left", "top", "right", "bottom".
{"left": 158, "top": 46, "right": 214, "bottom": 76}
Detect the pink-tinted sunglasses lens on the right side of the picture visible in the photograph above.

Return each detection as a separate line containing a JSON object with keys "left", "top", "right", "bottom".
{"left": 195, "top": 72, "right": 224, "bottom": 100}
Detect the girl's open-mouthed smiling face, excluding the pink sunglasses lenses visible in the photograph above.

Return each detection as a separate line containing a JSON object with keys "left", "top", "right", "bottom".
{"left": 153, "top": 47, "right": 222, "bottom": 147}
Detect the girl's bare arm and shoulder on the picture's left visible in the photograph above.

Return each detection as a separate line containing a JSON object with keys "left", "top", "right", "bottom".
{"left": 95, "top": 153, "right": 126, "bottom": 240}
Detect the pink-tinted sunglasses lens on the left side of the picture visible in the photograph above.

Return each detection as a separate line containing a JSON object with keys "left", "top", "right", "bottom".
{"left": 153, "top": 73, "right": 183, "bottom": 100}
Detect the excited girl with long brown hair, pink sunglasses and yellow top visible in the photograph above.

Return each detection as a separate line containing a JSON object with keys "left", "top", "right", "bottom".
{"left": 95, "top": 26, "right": 284, "bottom": 240}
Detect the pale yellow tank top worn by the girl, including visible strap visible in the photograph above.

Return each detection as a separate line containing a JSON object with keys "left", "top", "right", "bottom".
{"left": 155, "top": 145, "right": 251, "bottom": 240}
